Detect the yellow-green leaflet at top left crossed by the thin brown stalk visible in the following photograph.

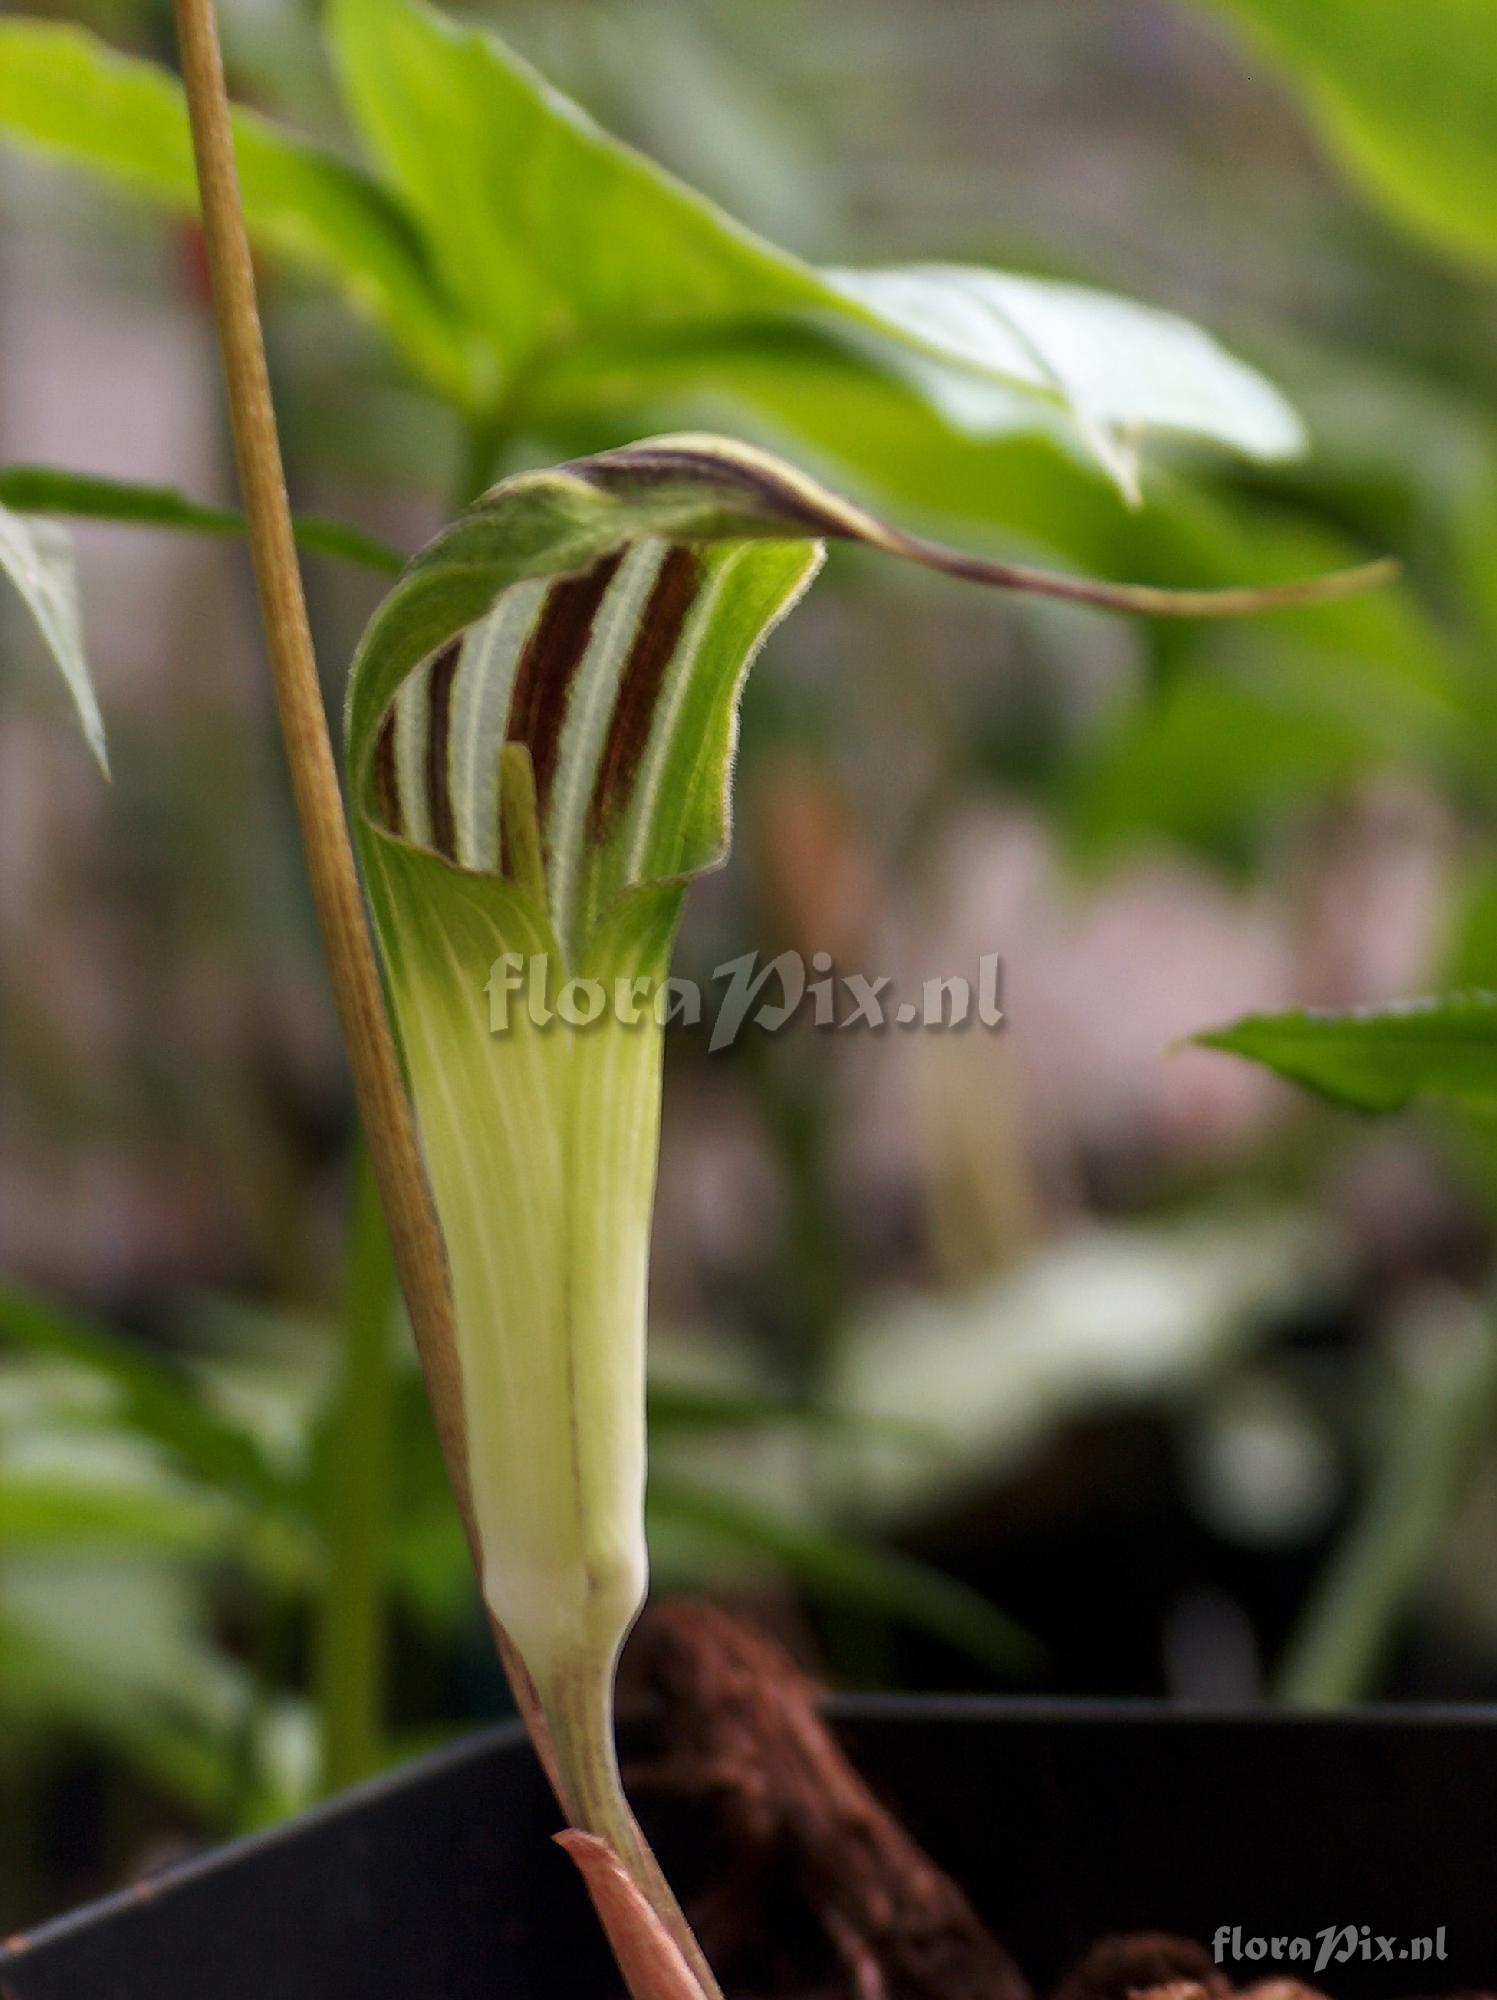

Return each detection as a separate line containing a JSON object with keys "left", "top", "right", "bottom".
{"left": 0, "top": 20, "right": 476, "bottom": 406}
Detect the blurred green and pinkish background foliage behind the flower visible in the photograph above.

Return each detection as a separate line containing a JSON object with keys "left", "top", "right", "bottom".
{"left": 0, "top": 0, "right": 1497, "bottom": 1924}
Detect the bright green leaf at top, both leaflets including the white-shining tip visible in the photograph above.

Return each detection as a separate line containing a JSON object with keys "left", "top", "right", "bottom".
{"left": 0, "top": 0, "right": 1303, "bottom": 488}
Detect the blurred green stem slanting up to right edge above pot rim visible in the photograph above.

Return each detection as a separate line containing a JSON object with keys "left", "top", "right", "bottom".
{"left": 1277, "top": 1332, "right": 1497, "bottom": 1708}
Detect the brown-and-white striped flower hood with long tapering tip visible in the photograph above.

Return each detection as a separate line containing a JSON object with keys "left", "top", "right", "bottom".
{"left": 362, "top": 436, "right": 1381, "bottom": 964}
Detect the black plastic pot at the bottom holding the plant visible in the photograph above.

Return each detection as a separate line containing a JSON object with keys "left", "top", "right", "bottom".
{"left": 0, "top": 1698, "right": 1497, "bottom": 2000}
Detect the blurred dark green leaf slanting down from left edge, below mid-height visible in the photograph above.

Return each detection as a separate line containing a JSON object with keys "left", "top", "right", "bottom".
{"left": 0, "top": 1284, "right": 282, "bottom": 1502}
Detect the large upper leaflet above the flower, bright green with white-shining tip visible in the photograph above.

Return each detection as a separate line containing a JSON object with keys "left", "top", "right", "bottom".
{"left": 330, "top": 0, "right": 1303, "bottom": 486}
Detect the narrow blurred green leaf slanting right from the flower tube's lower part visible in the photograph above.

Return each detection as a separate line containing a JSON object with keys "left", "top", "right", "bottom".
{"left": 650, "top": 1474, "right": 1039, "bottom": 1674}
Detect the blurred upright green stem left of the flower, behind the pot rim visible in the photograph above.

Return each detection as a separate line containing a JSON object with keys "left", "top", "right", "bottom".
{"left": 316, "top": 1144, "right": 394, "bottom": 1792}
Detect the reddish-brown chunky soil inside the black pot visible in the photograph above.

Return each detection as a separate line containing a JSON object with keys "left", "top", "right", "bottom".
{"left": 626, "top": 1602, "right": 1489, "bottom": 2000}
